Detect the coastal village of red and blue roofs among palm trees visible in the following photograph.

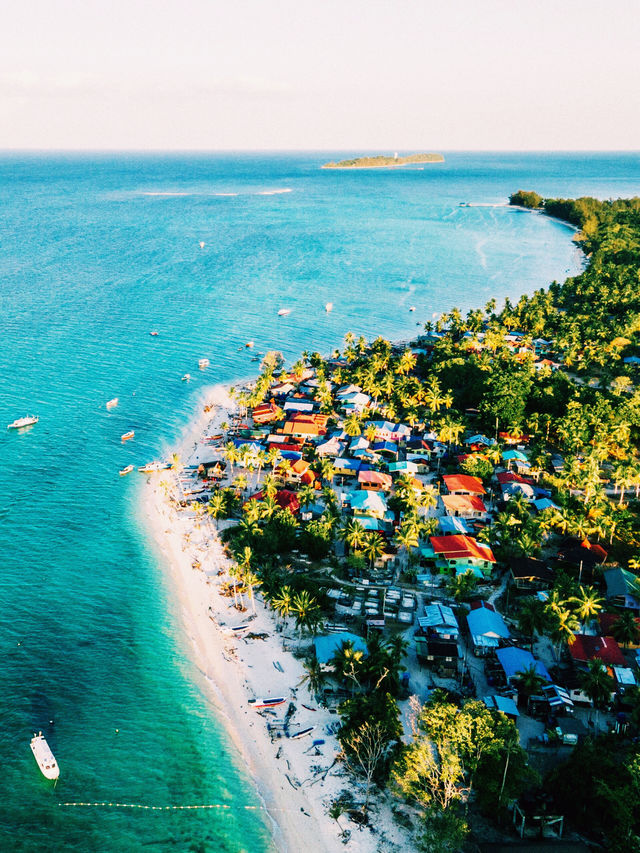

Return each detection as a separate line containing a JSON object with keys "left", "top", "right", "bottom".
{"left": 151, "top": 195, "right": 640, "bottom": 850}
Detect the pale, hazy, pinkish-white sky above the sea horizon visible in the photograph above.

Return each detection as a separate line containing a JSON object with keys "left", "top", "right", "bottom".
{"left": 0, "top": 0, "right": 640, "bottom": 150}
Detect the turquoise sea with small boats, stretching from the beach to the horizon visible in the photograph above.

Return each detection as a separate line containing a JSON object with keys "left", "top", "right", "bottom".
{"left": 0, "top": 152, "right": 640, "bottom": 853}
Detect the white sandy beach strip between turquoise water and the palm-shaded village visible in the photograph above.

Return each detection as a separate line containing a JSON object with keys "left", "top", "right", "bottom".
{"left": 142, "top": 386, "right": 401, "bottom": 853}
